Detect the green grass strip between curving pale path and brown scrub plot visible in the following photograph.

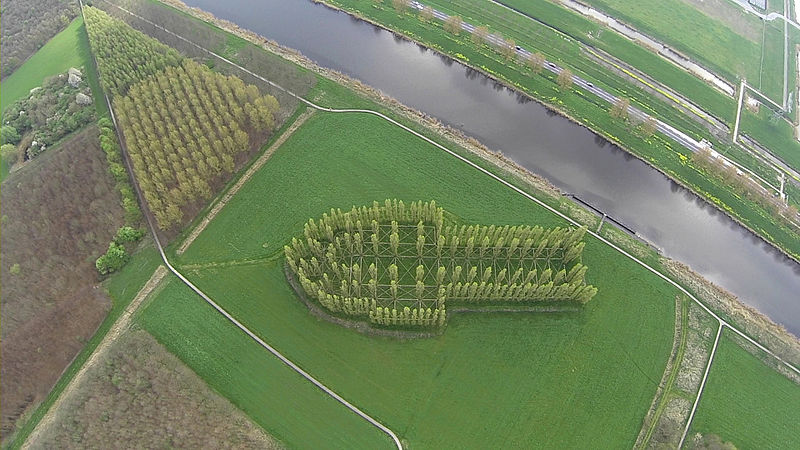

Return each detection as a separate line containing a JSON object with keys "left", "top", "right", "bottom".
{"left": 139, "top": 276, "right": 391, "bottom": 448}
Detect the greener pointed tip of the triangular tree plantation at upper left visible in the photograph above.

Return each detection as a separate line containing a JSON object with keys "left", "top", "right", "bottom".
{"left": 83, "top": 6, "right": 183, "bottom": 96}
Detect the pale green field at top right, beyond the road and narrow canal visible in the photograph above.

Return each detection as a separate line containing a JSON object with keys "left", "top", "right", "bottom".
{"left": 580, "top": 0, "right": 761, "bottom": 83}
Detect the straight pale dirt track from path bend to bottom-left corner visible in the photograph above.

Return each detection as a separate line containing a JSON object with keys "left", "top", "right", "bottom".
{"left": 22, "top": 266, "right": 168, "bottom": 449}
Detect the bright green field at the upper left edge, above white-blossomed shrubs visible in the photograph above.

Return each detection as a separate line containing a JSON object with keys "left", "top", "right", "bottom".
{"left": 0, "top": 16, "right": 90, "bottom": 113}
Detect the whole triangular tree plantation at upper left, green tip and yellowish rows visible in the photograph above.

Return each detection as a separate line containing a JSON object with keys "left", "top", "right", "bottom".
{"left": 86, "top": 8, "right": 279, "bottom": 229}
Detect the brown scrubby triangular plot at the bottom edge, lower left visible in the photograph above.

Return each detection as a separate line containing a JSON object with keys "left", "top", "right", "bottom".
{"left": 29, "top": 329, "right": 280, "bottom": 449}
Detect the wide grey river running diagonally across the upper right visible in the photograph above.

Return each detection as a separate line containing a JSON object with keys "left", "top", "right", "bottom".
{"left": 186, "top": 0, "right": 800, "bottom": 336}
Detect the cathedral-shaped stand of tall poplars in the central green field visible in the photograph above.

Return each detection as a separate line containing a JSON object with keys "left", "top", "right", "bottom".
{"left": 284, "top": 200, "right": 597, "bottom": 327}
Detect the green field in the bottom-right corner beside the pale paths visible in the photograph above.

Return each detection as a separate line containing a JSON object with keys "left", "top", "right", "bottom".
{"left": 689, "top": 330, "right": 800, "bottom": 449}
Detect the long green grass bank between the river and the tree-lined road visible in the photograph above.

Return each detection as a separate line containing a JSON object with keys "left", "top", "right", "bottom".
{"left": 318, "top": 0, "right": 800, "bottom": 258}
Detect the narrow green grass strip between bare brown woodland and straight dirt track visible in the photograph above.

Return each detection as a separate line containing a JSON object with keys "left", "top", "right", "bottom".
{"left": 4, "top": 245, "right": 161, "bottom": 449}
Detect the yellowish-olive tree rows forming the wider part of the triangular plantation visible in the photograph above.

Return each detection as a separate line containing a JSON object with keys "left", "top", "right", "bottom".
{"left": 114, "top": 59, "right": 279, "bottom": 229}
